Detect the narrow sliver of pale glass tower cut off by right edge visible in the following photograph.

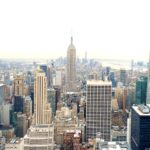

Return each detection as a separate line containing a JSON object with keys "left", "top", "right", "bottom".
{"left": 146, "top": 52, "right": 150, "bottom": 105}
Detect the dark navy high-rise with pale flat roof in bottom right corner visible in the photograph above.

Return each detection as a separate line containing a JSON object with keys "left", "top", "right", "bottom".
{"left": 131, "top": 105, "right": 150, "bottom": 150}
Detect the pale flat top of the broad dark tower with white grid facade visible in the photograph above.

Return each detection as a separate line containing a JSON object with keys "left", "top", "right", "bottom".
{"left": 87, "top": 80, "right": 112, "bottom": 86}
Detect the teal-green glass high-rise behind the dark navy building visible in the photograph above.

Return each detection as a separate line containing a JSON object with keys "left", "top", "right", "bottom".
{"left": 135, "top": 76, "right": 147, "bottom": 104}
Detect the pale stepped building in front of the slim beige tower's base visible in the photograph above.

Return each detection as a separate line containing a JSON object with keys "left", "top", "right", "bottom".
{"left": 24, "top": 125, "right": 54, "bottom": 150}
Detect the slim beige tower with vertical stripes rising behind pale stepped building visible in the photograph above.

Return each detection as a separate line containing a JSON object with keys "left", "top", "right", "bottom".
{"left": 34, "top": 69, "right": 51, "bottom": 125}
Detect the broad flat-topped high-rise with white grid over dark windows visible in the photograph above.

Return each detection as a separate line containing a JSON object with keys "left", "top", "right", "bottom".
{"left": 86, "top": 80, "right": 112, "bottom": 141}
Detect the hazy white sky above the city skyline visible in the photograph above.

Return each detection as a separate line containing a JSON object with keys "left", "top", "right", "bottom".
{"left": 0, "top": 0, "right": 150, "bottom": 60}
